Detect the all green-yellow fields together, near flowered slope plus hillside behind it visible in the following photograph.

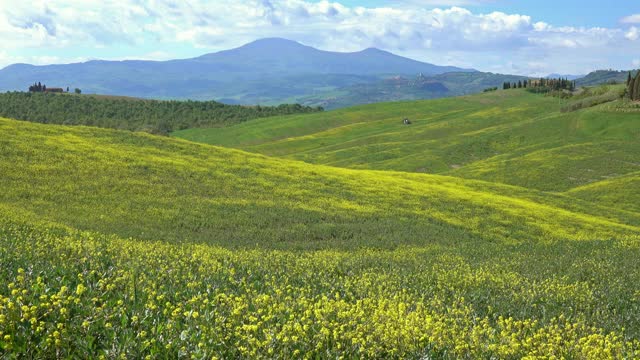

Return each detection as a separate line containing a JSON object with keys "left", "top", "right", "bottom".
{"left": 0, "top": 86, "right": 640, "bottom": 359}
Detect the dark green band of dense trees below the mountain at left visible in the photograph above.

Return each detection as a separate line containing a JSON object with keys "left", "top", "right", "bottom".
{"left": 0, "top": 92, "right": 323, "bottom": 134}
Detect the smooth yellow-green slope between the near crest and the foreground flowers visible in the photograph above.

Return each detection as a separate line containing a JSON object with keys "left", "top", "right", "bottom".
{"left": 0, "top": 116, "right": 640, "bottom": 248}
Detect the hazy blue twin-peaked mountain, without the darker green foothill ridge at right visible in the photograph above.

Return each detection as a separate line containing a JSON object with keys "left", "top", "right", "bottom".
{"left": 0, "top": 38, "right": 474, "bottom": 105}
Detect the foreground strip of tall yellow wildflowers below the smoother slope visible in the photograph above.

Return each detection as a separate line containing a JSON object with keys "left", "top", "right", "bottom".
{"left": 0, "top": 218, "right": 640, "bottom": 359}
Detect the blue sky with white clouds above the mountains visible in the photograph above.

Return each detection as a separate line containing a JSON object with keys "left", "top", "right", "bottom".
{"left": 0, "top": 0, "right": 640, "bottom": 75}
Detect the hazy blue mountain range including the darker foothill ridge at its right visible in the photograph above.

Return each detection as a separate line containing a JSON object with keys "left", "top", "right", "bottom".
{"left": 0, "top": 38, "right": 632, "bottom": 109}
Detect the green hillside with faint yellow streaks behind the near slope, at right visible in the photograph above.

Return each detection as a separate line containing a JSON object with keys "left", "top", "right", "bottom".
{"left": 174, "top": 88, "right": 640, "bottom": 192}
